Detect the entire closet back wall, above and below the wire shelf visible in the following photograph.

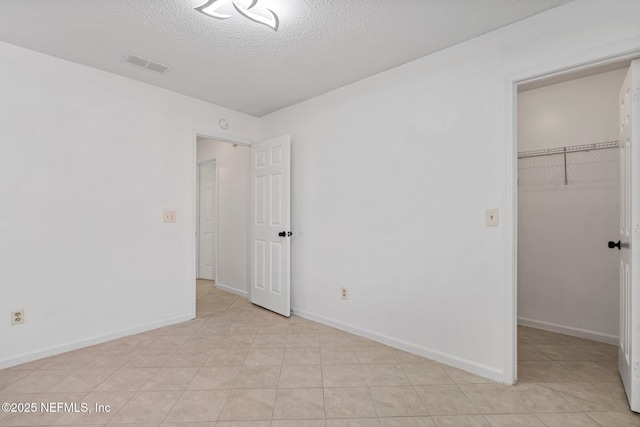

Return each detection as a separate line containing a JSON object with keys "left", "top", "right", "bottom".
{"left": 518, "top": 69, "right": 626, "bottom": 343}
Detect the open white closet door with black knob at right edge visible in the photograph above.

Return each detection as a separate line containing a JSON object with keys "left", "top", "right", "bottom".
{"left": 610, "top": 60, "right": 640, "bottom": 412}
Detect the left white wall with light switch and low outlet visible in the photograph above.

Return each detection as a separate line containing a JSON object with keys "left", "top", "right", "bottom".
{"left": 0, "top": 43, "right": 258, "bottom": 368}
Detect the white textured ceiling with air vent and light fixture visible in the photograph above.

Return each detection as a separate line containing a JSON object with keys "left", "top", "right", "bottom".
{"left": 0, "top": 0, "right": 571, "bottom": 116}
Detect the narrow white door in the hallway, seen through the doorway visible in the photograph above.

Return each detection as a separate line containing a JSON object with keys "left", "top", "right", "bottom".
{"left": 198, "top": 163, "right": 217, "bottom": 280}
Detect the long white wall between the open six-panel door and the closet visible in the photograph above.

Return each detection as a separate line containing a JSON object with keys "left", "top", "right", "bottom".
{"left": 260, "top": 0, "right": 640, "bottom": 381}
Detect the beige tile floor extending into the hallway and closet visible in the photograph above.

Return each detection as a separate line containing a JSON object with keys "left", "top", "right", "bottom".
{"left": 0, "top": 281, "right": 640, "bottom": 427}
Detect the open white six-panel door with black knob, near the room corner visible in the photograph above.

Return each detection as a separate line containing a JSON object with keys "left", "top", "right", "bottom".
{"left": 250, "top": 135, "right": 291, "bottom": 317}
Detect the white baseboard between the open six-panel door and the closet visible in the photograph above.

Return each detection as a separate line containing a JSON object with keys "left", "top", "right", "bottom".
{"left": 293, "top": 308, "right": 504, "bottom": 382}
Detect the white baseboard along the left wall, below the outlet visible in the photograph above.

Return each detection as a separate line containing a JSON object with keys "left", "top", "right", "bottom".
{"left": 0, "top": 314, "right": 194, "bottom": 369}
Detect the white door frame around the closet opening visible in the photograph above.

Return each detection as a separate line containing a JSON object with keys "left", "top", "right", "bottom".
{"left": 503, "top": 40, "right": 640, "bottom": 384}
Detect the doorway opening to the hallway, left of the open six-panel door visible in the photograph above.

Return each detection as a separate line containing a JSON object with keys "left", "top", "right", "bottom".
{"left": 195, "top": 136, "right": 250, "bottom": 317}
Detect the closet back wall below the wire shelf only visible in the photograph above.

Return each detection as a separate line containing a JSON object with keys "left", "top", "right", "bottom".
{"left": 518, "top": 150, "right": 620, "bottom": 343}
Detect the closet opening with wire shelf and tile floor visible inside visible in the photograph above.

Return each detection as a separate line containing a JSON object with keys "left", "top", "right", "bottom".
{"left": 517, "top": 64, "right": 627, "bottom": 382}
